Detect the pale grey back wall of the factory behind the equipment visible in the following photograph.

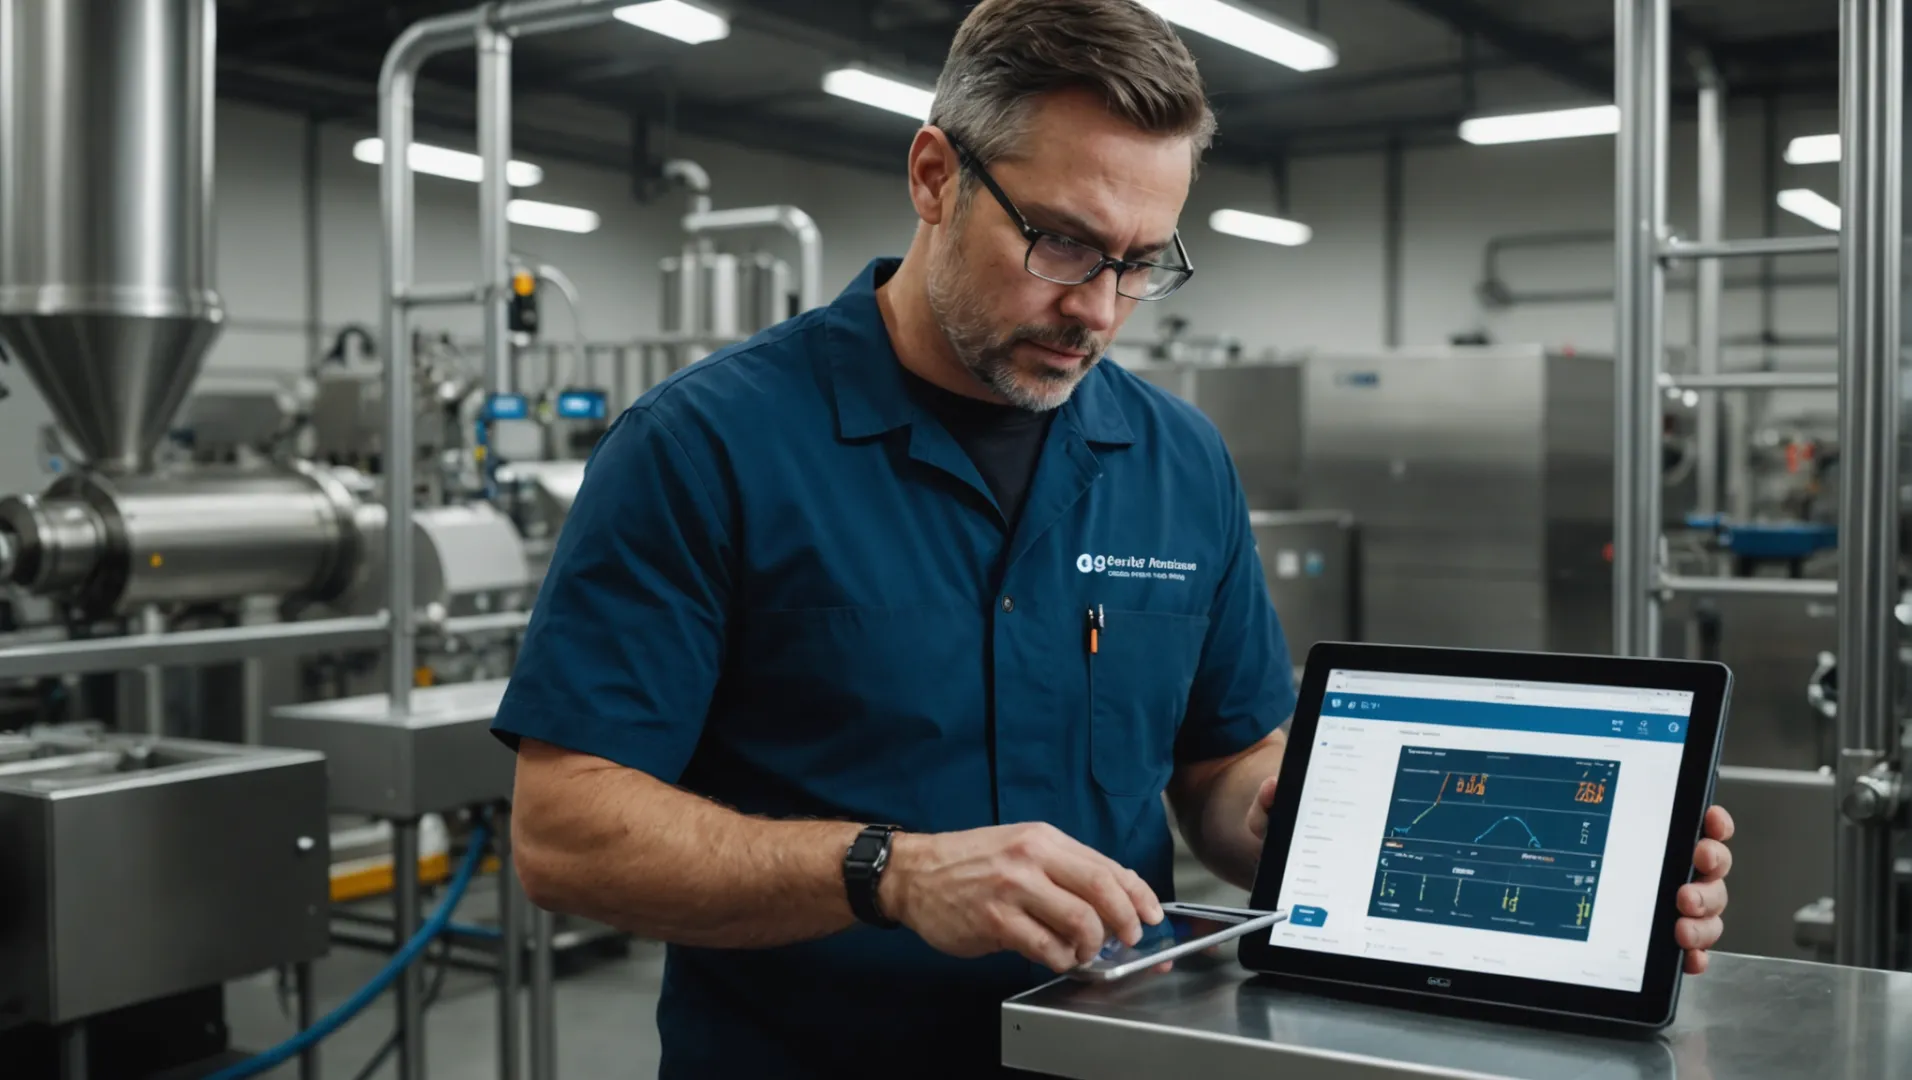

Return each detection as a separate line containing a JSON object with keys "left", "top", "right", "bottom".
{"left": 0, "top": 101, "right": 1837, "bottom": 491}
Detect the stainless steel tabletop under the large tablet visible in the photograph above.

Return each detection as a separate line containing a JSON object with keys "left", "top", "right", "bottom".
{"left": 1002, "top": 954, "right": 1912, "bottom": 1080}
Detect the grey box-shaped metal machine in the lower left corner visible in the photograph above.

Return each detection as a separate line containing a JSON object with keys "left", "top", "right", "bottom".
{"left": 0, "top": 728, "right": 327, "bottom": 1076}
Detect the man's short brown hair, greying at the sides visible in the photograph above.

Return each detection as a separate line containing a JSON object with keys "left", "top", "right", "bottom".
{"left": 929, "top": 0, "right": 1214, "bottom": 178}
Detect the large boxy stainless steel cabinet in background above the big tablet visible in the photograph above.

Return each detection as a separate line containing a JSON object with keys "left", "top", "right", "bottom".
{"left": 1302, "top": 348, "right": 1614, "bottom": 652}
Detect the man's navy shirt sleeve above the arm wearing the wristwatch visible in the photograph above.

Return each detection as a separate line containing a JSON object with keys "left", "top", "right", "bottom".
{"left": 491, "top": 407, "right": 732, "bottom": 782}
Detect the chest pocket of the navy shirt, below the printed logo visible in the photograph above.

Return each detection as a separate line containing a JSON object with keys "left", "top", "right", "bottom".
{"left": 1088, "top": 610, "right": 1208, "bottom": 795}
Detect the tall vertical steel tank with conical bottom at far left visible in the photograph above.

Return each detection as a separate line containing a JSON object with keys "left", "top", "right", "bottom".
{"left": 0, "top": 0, "right": 222, "bottom": 472}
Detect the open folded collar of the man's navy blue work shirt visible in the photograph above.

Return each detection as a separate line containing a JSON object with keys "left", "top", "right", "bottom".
{"left": 824, "top": 258, "right": 1136, "bottom": 445}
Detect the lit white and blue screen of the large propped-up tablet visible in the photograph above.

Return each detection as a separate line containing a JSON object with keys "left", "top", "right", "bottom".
{"left": 1270, "top": 669, "right": 1694, "bottom": 992}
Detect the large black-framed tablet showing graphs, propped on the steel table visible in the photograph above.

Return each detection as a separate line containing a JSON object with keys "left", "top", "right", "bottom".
{"left": 1241, "top": 644, "right": 1732, "bottom": 1028}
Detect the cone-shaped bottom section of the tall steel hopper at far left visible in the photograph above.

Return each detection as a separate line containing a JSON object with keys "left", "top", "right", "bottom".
{"left": 0, "top": 313, "right": 220, "bottom": 470}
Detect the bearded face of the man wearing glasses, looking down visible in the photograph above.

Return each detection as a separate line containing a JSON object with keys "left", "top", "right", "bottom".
{"left": 929, "top": 92, "right": 1193, "bottom": 411}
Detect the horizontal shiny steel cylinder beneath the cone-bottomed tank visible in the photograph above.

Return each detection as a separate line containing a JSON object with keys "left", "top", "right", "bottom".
{"left": 0, "top": 466, "right": 365, "bottom": 616}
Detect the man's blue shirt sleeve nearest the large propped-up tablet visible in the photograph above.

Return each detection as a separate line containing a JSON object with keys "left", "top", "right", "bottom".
{"left": 1176, "top": 454, "right": 1294, "bottom": 761}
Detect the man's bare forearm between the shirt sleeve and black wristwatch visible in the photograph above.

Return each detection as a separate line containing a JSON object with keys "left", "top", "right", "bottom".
{"left": 512, "top": 740, "right": 860, "bottom": 948}
